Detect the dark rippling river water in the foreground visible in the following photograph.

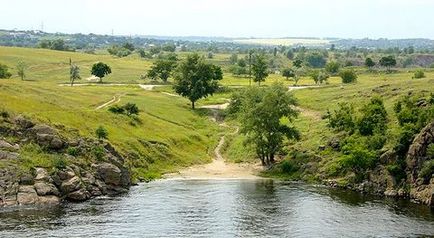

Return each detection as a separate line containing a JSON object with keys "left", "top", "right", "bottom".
{"left": 0, "top": 180, "right": 434, "bottom": 238}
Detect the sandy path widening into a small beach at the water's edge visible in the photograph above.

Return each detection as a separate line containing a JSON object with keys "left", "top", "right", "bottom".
{"left": 163, "top": 104, "right": 262, "bottom": 179}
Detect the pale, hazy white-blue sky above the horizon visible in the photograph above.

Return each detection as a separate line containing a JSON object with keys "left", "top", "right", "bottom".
{"left": 0, "top": 0, "right": 434, "bottom": 39}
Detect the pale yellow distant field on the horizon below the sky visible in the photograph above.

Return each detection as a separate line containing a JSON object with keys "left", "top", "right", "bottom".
{"left": 234, "top": 38, "right": 330, "bottom": 46}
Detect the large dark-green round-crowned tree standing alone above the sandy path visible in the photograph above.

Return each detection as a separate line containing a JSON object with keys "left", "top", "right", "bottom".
{"left": 173, "top": 54, "right": 223, "bottom": 109}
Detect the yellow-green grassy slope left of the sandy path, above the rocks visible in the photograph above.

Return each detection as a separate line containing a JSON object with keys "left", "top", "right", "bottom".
{"left": 0, "top": 47, "right": 219, "bottom": 179}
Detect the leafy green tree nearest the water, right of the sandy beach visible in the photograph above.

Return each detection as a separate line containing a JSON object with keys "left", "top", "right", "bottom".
{"left": 231, "top": 84, "right": 300, "bottom": 165}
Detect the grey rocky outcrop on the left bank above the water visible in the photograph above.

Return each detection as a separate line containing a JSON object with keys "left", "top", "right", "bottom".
{"left": 0, "top": 116, "right": 131, "bottom": 207}
